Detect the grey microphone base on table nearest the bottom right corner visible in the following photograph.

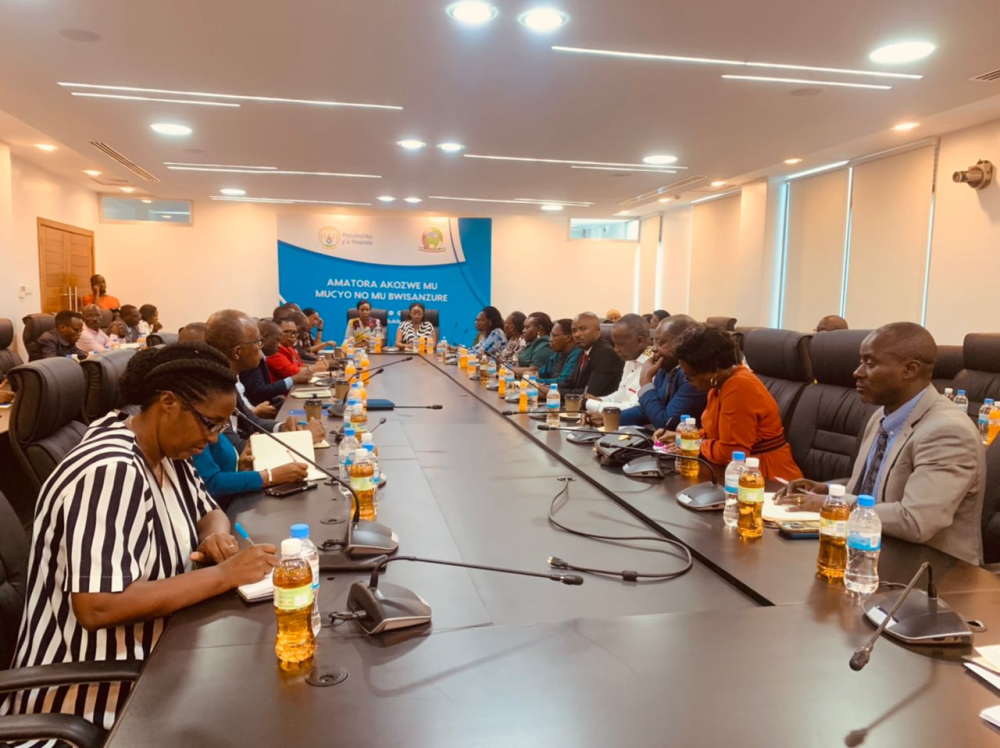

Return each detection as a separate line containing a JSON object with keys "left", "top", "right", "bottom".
{"left": 863, "top": 590, "right": 972, "bottom": 646}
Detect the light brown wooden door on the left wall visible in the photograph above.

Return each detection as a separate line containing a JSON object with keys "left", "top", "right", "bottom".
{"left": 38, "top": 218, "right": 94, "bottom": 314}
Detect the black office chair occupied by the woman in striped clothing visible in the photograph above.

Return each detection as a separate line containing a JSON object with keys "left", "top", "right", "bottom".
{"left": 0, "top": 493, "right": 142, "bottom": 748}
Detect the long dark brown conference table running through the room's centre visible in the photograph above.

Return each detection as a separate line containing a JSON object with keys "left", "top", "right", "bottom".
{"left": 108, "top": 356, "right": 1000, "bottom": 748}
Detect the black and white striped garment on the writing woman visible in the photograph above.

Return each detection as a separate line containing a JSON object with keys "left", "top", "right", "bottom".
{"left": 3, "top": 413, "right": 216, "bottom": 728}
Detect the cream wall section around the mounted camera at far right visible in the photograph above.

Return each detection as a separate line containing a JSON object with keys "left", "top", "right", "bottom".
{"left": 926, "top": 121, "right": 1000, "bottom": 345}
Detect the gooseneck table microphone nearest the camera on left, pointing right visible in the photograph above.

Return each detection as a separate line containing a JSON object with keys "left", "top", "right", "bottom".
{"left": 347, "top": 556, "right": 583, "bottom": 635}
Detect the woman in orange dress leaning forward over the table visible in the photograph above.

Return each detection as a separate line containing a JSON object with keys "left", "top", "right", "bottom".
{"left": 657, "top": 325, "right": 802, "bottom": 480}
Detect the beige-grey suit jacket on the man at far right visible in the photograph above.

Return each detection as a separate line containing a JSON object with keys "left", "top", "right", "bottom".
{"left": 848, "top": 386, "right": 986, "bottom": 566}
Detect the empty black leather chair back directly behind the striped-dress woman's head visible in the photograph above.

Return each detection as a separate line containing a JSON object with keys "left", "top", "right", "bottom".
{"left": 8, "top": 358, "right": 87, "bottom": 495}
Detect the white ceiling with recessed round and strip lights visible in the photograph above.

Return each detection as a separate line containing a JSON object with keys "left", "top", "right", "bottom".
{"left": 0, "top": 0, "right": 1000, "bottom": 216}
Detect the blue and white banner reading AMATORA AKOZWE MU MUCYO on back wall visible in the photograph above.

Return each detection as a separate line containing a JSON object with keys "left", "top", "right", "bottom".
{"left": 278, "top": 213, "right": 493, "bottom": 342}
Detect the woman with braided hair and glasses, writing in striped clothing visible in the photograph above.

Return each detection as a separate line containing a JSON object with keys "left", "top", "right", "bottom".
{"left": 3, "top": 343, "right": 278, "bottom": 728}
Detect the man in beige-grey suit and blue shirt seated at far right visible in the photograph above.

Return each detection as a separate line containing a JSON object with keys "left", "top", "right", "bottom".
{"left": 778, "top": 322, "right": 986, "bottom": 565}
